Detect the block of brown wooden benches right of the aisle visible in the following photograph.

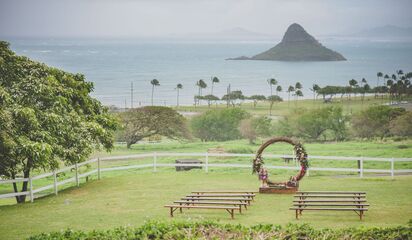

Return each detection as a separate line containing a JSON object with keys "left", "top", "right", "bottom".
{"left": 289, "top": 191, "right": 369, "bottom": 220}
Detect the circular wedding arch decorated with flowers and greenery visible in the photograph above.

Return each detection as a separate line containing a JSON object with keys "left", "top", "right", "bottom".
{"left": 253, "top": 137, "right": 309, "bottom": 187}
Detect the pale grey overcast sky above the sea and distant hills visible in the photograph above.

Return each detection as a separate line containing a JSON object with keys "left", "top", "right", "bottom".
{"left": 0, "top": 0, "right": 412, "bottom": 37}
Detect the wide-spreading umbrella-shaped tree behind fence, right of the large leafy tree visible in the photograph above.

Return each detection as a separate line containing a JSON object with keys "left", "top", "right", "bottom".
{"left": 120, "top": 106, "right": 190, "bottom": 148}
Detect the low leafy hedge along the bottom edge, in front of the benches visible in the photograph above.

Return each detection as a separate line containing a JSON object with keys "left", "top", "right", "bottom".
{"left": 29, "top": 221, "right": 412, "bottom": 240}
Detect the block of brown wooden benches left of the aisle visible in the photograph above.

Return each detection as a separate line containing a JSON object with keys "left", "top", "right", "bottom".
{"left": 164, "top": 190, "right": 256, "bottom": 219}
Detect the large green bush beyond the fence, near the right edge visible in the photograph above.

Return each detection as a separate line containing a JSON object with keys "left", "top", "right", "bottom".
{"left": 351, "top": 106, "right": 405, "bottom": 138}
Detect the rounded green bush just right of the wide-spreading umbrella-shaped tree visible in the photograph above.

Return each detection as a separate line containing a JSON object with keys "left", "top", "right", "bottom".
{"left": 191, "top": 108, "right": 248, "bottom": 141}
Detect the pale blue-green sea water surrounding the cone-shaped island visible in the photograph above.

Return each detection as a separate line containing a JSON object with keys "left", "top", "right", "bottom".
{"left": 4, "top": 39, "right": 412, "bottom": 107}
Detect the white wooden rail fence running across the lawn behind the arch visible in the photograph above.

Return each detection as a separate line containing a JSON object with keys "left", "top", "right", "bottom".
{"left": 0, "top": 152, "right": 412, "bottom": 202}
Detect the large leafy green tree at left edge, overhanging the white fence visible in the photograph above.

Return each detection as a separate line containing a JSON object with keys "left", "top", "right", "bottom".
{"left": 0, "top": 41, "right": 117, "bottom": 203}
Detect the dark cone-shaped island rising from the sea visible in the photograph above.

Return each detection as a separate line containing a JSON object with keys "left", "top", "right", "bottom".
{"left": 228, "top": 23, "right": 346, "bottom": 61}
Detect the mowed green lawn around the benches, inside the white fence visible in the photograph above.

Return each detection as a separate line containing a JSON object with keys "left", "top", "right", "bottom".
{"left": 0, "top": 169, "right": 412, "bottom": 239}
